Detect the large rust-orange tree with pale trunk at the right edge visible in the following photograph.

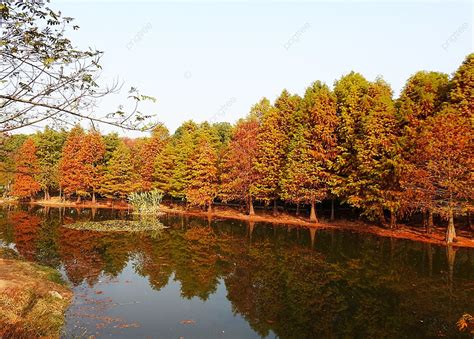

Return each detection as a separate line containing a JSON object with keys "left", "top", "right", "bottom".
{"left": 408, "top": 106, "right": 474, "bottom": 243}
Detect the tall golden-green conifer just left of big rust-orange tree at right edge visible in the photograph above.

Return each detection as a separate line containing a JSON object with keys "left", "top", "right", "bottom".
{"left": 346, "top": 79, "right": 400, "bottom": 228}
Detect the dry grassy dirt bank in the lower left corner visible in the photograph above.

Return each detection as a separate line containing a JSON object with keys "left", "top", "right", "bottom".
{"left": 0, "top": 248, "right": 72, "bottom": 338}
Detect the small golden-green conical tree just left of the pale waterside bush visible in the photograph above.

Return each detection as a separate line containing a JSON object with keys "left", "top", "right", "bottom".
{"left": 99, "top": 142, "right": 139, "bottom": 199}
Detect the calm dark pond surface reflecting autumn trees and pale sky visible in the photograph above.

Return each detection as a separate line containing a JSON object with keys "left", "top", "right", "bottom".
{"left": 0, "top": 208, "right": 474, "bottom": 338}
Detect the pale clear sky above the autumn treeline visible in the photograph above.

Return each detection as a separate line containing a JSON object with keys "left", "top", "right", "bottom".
{"left": 52, "top": 0, "right": 474, "bottom": 136}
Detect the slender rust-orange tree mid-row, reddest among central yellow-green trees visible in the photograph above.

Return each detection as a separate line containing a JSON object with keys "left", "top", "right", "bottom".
{"left": 220, "top": 115, "right": 259, "bottom": 215}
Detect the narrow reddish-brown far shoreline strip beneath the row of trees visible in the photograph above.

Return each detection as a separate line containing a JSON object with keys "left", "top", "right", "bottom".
{"left": 0, "top": 200, "right": 474, "bottom": 248}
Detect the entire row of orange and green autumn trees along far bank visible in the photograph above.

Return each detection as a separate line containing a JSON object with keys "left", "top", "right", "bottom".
{"left": 0, "top": 54, "right": 474, "bottom": 242}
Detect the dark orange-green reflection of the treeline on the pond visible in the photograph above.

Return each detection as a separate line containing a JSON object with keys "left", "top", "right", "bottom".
{"left": 0, "top": 209, "right": 474, "bottom": 338}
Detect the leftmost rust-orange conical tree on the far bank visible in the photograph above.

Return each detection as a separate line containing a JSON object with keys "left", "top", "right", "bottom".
{"left": 12, "top": 138, "right": 41, "bottom": 199}
